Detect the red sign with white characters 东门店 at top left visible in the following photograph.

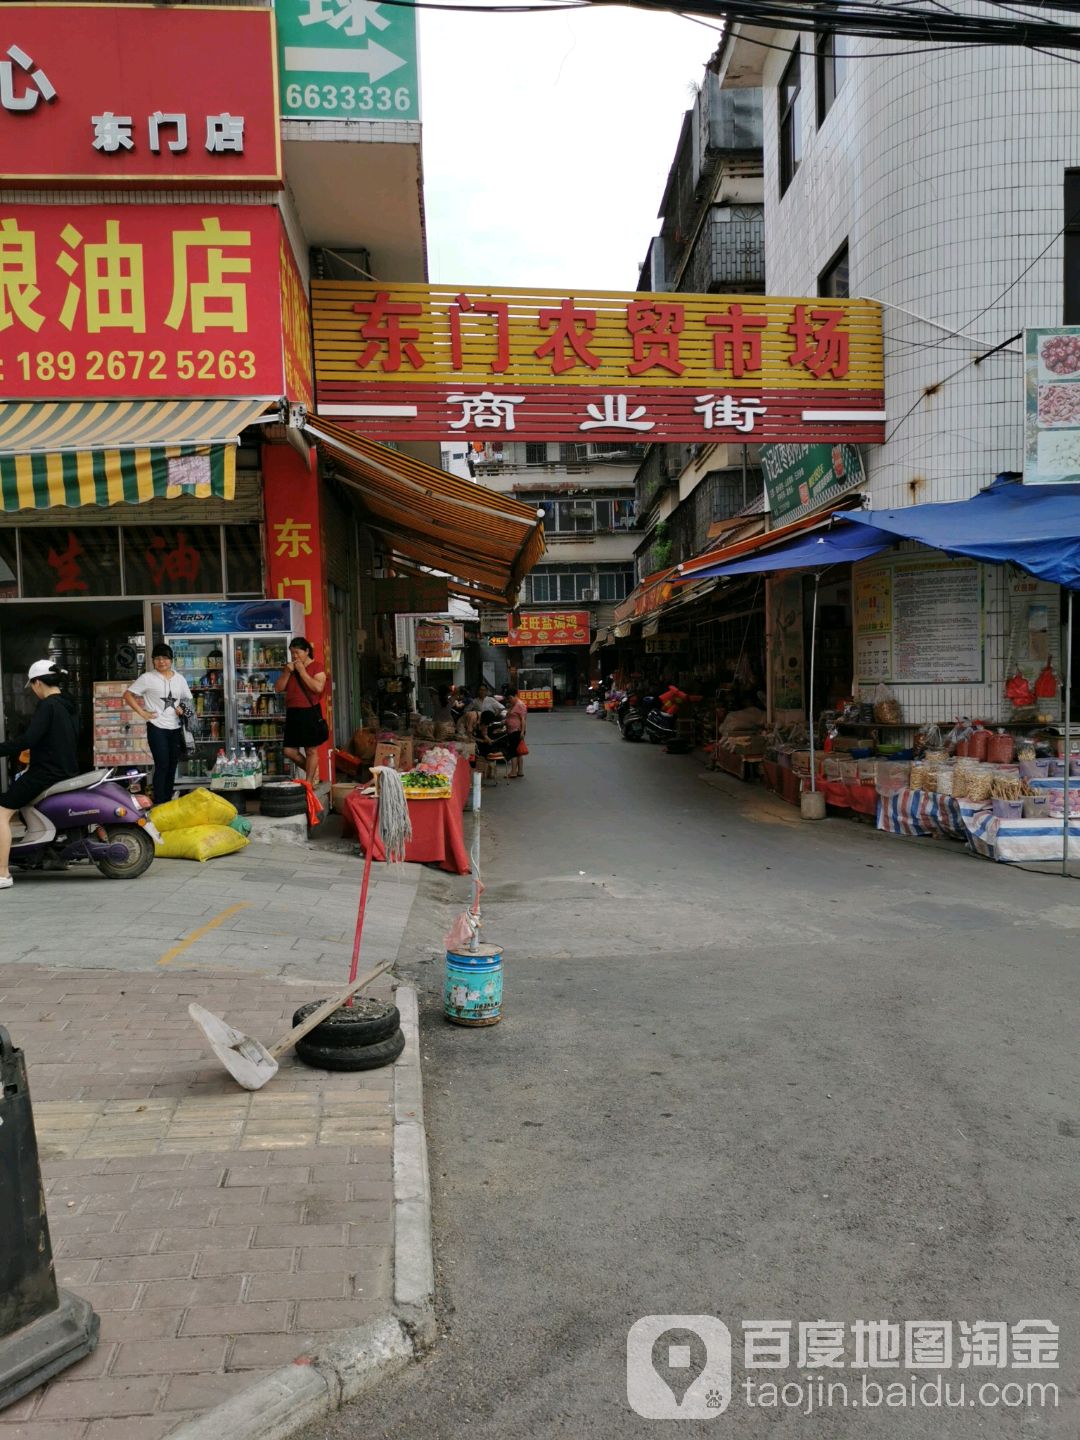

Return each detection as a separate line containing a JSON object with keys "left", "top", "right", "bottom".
{"left": 0, "top": 4, "right": 281, "bottom": 187}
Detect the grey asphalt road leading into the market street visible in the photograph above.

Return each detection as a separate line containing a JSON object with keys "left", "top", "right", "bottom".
{"left": 298, "top": 714, "right": 1080, "bottom": 1440}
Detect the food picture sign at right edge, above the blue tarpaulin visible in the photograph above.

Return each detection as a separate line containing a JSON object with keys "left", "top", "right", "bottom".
{"left": 1024, "top": 325, "right": 1080, "bottom": 485}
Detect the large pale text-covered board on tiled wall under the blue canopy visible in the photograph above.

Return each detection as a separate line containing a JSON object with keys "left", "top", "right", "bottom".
{"left": 854, "top": 556, "right": 985, "bottom": 685}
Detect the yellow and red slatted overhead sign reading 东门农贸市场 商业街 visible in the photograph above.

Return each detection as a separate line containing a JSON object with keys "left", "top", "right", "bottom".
{"left": 311, "top": 279, "right": 884, "bottom": 445}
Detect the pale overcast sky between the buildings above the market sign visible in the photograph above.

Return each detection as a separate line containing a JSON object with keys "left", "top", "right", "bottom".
{"left": 420, "top": 6, "right": 720, "bottom": 289}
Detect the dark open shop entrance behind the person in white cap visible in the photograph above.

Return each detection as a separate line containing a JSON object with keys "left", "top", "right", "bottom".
{"left": 0, "top": 600, "right": 145, "bottom": 769}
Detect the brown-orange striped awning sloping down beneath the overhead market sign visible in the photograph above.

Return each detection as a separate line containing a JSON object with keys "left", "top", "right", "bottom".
{"left": 304, "top": 416, "right": 544, "bottom": 606}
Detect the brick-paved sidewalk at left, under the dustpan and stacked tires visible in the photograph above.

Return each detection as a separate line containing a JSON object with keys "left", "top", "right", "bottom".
{"left": 0, "top": 847, "right": 440, "bottom": 1440}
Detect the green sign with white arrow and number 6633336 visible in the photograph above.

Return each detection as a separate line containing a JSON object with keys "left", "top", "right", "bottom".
{"left": 275, "top": 0, "right": 420, "bottom": 120}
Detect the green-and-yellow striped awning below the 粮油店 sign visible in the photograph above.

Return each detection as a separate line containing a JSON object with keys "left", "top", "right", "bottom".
{"left": 0, "top": 399, "right": 274, "bottom": 514}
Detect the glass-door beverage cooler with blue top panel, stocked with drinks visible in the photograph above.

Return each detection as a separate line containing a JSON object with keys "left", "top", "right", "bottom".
{"left": 161, "top": 600, "right": 304, "bottom": 786}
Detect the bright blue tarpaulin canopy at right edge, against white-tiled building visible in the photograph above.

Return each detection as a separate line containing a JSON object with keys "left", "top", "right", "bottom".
{"left": 852, "top": 475, "right": 1080, "bottom": 590}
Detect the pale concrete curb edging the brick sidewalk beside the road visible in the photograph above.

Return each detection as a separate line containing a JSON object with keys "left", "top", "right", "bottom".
{"left": 170, "top": 985, "right": 436, "bottom": 1440}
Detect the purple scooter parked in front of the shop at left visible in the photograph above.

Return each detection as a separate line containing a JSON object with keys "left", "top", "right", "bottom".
{"left": 10, "top": 770, "right": 161, "bottom": 880}
